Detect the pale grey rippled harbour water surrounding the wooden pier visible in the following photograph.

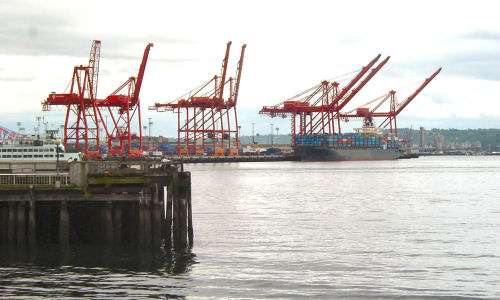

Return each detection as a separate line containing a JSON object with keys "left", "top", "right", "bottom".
{"left": 0, "top": 157, "right": 500, "bottom": 299}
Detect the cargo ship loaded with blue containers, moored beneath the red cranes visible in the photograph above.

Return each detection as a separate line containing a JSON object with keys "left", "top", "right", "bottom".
{"left": 293, "top": 127, "right": 404, "bottom": 161}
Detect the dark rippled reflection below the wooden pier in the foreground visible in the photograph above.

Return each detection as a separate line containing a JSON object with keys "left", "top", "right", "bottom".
{"left": 0, "top": 245, "right": 197, "bottom": 299}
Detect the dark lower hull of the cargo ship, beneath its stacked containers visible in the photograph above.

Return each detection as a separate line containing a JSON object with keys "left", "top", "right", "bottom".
{"left": 294, "top": 145, "right": 402, "bottom": 161}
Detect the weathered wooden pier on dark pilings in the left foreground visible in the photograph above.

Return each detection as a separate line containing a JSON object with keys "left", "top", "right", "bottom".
{"left": 0, "top": 161, "right": 193, "bottom": 249}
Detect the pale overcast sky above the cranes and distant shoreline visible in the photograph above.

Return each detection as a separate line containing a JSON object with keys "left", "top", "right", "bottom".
{"left": 0, "top": 0, "right": 500, "bottom": 136}
